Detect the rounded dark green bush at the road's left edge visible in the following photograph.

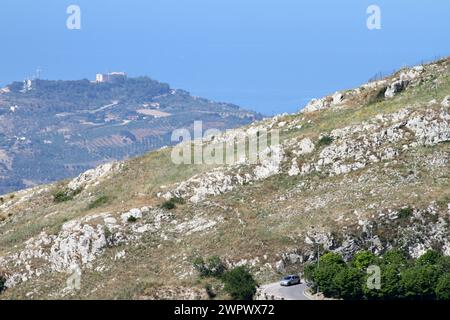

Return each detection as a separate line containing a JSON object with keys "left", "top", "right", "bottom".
{"left": 222, "top": 266, "right": 257, "bottom": 300}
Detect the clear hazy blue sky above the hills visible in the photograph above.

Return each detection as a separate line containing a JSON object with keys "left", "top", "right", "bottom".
{"left": 0, "top": 0, "right": 450, "bottom": 114}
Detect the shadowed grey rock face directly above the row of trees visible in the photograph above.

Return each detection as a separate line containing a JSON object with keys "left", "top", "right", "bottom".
{"left": 275, "top": 203, "right": 450, "bottom": 273}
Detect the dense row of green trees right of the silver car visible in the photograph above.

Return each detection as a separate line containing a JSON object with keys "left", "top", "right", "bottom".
{"left": 305, "top": 250, "right": 450, "bottom": 300}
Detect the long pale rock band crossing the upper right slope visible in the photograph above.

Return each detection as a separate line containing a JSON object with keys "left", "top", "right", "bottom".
{"left": 164, "top": 108, "right": 450, "bottom": 203}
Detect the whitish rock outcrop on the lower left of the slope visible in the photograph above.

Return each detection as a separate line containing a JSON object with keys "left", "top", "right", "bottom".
{"left": 0, "top": 206, "right": 221, "bottom": 288}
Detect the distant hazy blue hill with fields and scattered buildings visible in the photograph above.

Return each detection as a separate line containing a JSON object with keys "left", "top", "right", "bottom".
{"left": 0, "top": 77, "right": 261, "bottom": 194}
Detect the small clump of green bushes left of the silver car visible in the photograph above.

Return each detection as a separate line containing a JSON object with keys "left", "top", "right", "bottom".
{"left": 194, "top": 256, "right": 257, "bottom": 300}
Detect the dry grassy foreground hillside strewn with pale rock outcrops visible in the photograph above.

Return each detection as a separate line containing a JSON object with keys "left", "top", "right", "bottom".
{"left": 0, "top": 59, "right": 450, "bottom": 299}
